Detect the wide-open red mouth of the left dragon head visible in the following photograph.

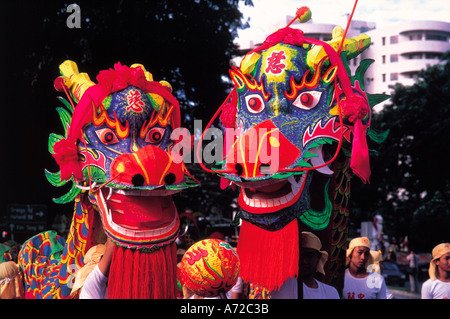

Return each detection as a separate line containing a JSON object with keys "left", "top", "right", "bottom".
{"left": 95, "top": 187, "right": 179, "bottom": 245}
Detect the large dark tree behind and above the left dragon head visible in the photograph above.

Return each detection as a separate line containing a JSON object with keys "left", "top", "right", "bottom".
{"left": 0, "top": 0, "right": 252, "bottom": 230}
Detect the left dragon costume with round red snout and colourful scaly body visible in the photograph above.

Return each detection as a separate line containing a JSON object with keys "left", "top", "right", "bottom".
{"left": 19, "top": 61, "right": 198, "bottom": 298}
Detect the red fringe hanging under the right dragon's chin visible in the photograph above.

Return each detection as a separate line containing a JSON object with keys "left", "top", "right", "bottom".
{"left": 237, "top": 220, "right": 299, "bottom": 290}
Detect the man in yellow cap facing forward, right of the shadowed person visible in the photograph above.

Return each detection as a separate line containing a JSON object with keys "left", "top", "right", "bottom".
{"left": 342, "top": 237, "right": 386, "bottom": 299}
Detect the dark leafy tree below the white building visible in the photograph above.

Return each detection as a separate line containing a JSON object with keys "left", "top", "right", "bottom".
{"left": 352, "top": 52, "right": 450, "bottom": 251}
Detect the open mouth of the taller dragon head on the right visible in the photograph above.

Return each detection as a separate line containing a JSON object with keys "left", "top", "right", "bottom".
{"left": 235, "top": 173, "right": 307, "bottom": 214}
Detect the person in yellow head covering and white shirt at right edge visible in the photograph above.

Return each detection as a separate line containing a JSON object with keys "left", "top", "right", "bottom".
{"left": 422, "top": 243, "right": 450, "bottom": 299}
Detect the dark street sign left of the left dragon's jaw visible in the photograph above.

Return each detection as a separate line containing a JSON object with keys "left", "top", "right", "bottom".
{"left": 7, "top": 204, "right": 47, "bottom": 234}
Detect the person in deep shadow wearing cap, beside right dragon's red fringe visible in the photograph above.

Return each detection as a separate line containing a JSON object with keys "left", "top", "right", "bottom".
{"left": 271, "top": 232, "right": 339, "bottom": 299}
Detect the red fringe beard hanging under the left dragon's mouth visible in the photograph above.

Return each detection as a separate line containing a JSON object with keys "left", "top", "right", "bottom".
{"left": 108, "top": 243, "right": 177, "bottom": 299}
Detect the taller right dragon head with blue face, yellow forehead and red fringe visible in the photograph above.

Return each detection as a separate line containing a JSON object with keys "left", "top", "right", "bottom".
{"left": 197, "top": 2, "right": 388, "bottom": 298}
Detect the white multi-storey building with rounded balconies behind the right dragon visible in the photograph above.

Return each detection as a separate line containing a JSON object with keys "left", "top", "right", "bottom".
{"left": 362, "top": 21, "right": 450, "bottom": 94}
